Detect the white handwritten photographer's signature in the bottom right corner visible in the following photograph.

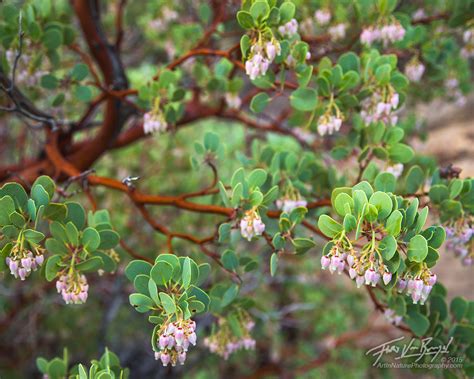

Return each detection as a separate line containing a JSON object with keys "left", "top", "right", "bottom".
{"left": 365, "top": 336, "right": 453, "bottom": 366}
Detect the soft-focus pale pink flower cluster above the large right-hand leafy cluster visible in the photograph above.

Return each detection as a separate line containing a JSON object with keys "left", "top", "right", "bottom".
{"left": 360, "top": 91, "right": 400, "bottom": 125}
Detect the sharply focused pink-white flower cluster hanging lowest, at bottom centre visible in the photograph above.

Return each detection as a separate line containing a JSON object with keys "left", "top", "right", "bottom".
{"left": 155, "top": 319, "right": 197, "bottom": 367}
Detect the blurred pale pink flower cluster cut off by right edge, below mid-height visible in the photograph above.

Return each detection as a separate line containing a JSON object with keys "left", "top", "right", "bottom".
{"left": 445, "top": 220, "right": 474, "bottom": 266}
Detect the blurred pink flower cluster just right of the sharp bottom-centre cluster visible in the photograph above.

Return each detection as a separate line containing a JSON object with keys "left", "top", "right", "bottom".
{"left": 204, "top": 313, "right": 256, "bottom": 360}
